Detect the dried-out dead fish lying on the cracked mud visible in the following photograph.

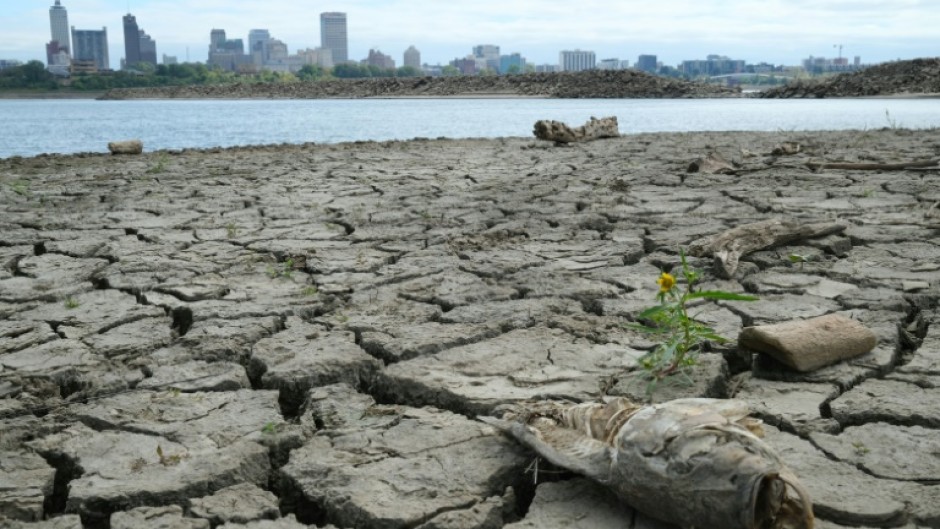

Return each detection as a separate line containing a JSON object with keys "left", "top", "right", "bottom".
{"left": 480, "top": 398, "right": 813, "bottom": 529}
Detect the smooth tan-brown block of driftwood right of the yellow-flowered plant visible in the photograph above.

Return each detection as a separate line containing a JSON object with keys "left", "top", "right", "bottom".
{"left": 738, "top": 314, "right": 878, "bottom": 373}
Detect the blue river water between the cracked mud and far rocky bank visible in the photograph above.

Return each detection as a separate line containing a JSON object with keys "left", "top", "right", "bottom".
{"left": 0, "top": 98, "right": 940, "bottom": 158}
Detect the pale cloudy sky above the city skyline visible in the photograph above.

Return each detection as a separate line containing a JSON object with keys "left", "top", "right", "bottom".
{"left": 0, "top": 0, "right": 940, "bottom": 68}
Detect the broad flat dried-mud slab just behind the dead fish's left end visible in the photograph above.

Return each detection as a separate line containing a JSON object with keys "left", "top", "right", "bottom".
{"left": 376, "top": 327, "right": 642, "bottom": 415}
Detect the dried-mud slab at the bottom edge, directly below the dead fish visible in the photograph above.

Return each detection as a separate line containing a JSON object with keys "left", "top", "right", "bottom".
{"left": 505, "top": 478, "right": 636, "bottom": 529}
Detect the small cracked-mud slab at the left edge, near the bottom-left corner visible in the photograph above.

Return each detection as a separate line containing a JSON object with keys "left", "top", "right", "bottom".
{"left": 0, "top": 451, "right": 55, "bottom": 522}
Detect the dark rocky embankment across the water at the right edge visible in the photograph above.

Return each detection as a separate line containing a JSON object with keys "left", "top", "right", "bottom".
{"left": 758, "top": 59, "right": 940, "bottom": 98}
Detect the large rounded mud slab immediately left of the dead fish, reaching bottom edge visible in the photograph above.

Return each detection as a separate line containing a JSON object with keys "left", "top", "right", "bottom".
{"left": 281, "top": 407, "right": 528, "bottom": 528}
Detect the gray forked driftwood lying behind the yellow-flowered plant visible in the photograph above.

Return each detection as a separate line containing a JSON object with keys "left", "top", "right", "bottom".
{"left": 688, "top": 219, "right": 846, "bottom": 279}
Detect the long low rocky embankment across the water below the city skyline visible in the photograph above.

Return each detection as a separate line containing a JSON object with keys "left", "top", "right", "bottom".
{"left": 100, "top": 70, "right": 740, "bottom": 99}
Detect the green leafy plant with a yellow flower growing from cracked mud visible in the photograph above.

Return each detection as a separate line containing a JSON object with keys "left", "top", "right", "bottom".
{"left": 636, "top": 248, "right": 757, "bottom": 393}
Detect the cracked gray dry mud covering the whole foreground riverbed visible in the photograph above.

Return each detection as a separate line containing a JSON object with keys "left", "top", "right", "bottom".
{"left": 0, "top": 130, "right": 940, "bottom": 529}
